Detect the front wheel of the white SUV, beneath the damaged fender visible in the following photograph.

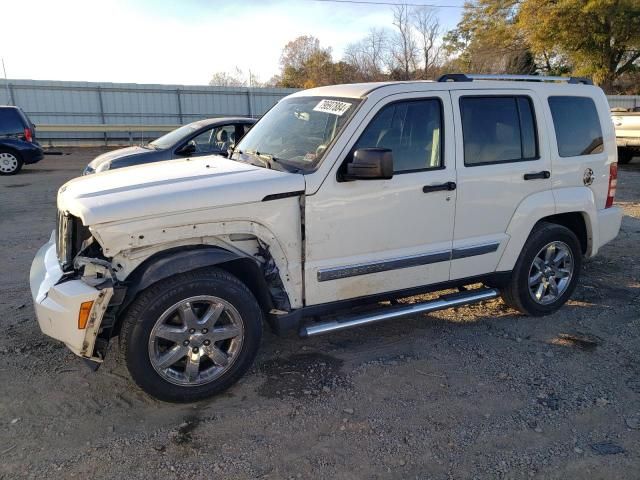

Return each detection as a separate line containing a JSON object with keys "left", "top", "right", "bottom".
{"left": 120, "top": 268, "right": 262, "bottom": 402}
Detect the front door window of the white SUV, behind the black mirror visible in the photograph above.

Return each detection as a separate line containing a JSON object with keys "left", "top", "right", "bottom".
{"left": 354, "top": 99, "right": 443, "bottom": 173}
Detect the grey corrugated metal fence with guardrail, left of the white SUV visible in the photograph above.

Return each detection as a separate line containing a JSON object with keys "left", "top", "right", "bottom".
{"left": 0, "top": 79, "right": 296, "bottom": 146}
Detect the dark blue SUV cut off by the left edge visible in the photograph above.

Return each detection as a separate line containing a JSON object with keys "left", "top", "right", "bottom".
{"left": 0, "top": 106, "right": 44, "bottom": 175}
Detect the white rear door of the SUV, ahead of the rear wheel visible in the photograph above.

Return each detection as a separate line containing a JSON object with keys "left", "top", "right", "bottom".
{"left": 451, "top": 90, "right": 553, "bottom": 279}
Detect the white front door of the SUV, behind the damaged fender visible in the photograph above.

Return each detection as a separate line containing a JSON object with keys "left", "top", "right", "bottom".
{"left": 305, "top": 92, "right": 456, "bottom": 305}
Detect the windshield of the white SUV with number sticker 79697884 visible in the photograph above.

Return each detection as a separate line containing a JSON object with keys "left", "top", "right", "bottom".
{"left": 232, "top": 97, "right": 360, "bottom": 172}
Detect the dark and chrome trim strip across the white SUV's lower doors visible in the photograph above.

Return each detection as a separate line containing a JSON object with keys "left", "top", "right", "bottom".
{"left": 318, "top": 242, "right": 500, "bottom": 282}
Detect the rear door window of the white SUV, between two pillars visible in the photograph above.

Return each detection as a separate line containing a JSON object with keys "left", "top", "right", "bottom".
{"left": 460, "top": 96, "right": 538, "bottom": 166}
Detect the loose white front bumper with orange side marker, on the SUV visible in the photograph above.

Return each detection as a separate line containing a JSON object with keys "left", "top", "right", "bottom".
{"left": 29, "top": 232, "right": 113, "bottom": 362}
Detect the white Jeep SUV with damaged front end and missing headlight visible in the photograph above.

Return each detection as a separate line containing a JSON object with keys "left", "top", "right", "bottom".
{"left": 31, "top": 74, "right": 622, "bottom": 401}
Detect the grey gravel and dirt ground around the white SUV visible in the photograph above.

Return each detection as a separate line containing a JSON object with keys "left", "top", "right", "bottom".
{"left": 0, "top": 149, "right": 640, "bottom": 479}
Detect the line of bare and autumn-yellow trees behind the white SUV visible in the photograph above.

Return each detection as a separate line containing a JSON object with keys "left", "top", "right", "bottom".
{"left": 210, "top": 0, "right": 640, "bottom": 94}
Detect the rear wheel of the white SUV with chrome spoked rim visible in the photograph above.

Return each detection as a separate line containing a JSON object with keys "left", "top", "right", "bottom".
{"left": 502, "top": 222, "right": 582, "bottom": 317}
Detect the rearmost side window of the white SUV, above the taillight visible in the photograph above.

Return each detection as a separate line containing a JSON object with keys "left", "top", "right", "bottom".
{"left": 549, "top": 97, "right": 604, "bottom": 157}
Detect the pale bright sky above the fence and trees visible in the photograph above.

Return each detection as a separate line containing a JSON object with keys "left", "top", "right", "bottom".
{"left": 0, "top": 0, "right": 464, "bottom": 85}
